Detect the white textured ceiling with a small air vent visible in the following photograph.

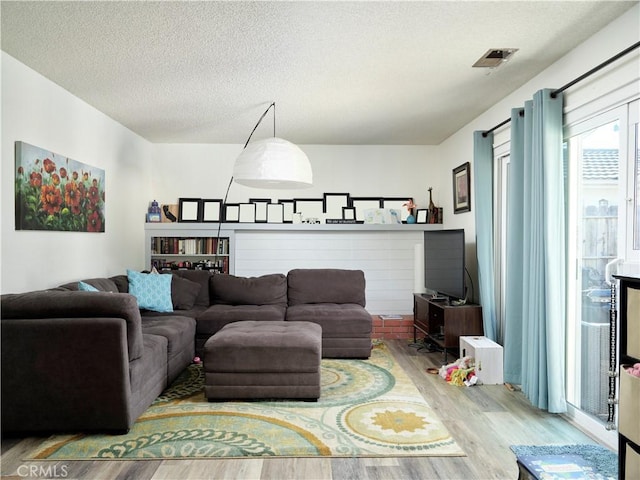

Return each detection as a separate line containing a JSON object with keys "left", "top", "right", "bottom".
{"left": 1, "top": 1, "right": 637, "bottom": 145}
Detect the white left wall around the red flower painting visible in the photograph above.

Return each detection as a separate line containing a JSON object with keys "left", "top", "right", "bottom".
{"left": 0, "top": 52, "right": 151, "bottom": 293}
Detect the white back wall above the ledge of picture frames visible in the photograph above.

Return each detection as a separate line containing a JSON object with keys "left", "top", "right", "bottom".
{"left": 152, "top": 144, "right": 441, "bottom": 208}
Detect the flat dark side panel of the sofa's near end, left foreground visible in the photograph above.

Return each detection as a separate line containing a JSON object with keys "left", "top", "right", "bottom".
{"left": 0, "top": 312, "right": 135, "bottom": 433}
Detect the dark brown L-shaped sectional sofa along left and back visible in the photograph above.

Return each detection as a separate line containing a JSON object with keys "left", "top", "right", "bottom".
{"left": 0, "top": 269, "right": 372, "bottom": 434}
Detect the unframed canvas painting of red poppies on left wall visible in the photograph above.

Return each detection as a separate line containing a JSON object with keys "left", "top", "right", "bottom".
{"left": 15, "top": 142, "right": 105, "bottom": 232}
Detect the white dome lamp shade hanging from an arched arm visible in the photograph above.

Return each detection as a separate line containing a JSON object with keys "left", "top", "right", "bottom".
{"left": 233, "top": 137, "right": 313, "bottom": 189}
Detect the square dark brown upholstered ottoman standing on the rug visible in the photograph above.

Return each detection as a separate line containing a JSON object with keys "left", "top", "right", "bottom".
{"left": 204, "top": 321, "right": 322, "bottom": 401}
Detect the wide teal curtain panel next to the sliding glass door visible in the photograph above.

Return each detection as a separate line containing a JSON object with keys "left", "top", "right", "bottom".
{"left": 504, "top": 90, "right": 567, "bottom": 413}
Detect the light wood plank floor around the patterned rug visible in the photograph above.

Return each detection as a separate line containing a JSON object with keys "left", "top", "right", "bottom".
{"left": 0, "top": 340, "right": 595, "bottom": 480}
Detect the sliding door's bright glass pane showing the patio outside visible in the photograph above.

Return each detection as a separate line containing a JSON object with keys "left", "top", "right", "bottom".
{"left": 565, "top": 108, "right": 626, "bottom": 423}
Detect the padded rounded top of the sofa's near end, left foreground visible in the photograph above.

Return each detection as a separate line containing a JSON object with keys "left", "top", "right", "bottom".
{"left": 0, "top": 290, "right": 144, "bottom": 361}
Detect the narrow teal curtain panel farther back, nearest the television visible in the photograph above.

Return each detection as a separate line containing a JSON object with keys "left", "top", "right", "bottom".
{"left": 473, "top": 131, "right": 498, "bottom": 341}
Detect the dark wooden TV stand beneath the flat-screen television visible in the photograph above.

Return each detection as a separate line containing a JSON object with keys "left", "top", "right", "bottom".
{"left": 413, "top": 293, "right": 484, "bottom": 360}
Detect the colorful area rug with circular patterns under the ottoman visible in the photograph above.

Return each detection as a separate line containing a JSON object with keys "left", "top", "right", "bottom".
{"left": 29, "top": 344, "right": 465, "bottom": 460}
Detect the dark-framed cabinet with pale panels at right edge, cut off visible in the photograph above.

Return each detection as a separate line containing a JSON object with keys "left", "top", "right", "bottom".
{"left": 615, "top": 275, "right": 640, "bottom": 480}
